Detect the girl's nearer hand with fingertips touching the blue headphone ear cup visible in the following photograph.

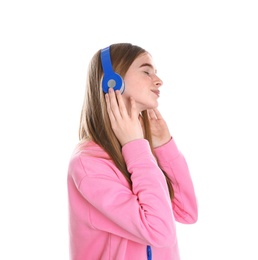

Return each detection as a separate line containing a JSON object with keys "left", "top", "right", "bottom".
{"left": 105, "top": 88, "right": 143, "bottom": 146}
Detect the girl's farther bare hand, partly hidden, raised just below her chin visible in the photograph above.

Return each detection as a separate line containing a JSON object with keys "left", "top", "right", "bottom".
{"left": 148, "top": 108, "right": 171, "bottom": 148}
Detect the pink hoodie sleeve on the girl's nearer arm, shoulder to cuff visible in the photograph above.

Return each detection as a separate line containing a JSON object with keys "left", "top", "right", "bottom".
{"left": 71, "top": 139, "right": 177, "bottom": 247}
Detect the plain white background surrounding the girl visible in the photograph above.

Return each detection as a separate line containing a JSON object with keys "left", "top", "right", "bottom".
{"left": 0, "top": 0, "right": 258, "bottom": 260}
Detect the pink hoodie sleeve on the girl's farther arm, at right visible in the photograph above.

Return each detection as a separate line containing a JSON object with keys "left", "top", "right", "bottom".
{"left": 154, "top": 139, "right": 198, "bottom": 224}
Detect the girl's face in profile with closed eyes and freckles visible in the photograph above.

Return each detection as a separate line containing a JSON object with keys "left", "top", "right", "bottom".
{"left": 122, "top": 53, "right": 163, "bottom": 112}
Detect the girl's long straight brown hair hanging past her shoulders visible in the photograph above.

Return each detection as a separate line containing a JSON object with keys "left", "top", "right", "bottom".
{"left": 79, "top": 43, "right": 173, "bottom": 199}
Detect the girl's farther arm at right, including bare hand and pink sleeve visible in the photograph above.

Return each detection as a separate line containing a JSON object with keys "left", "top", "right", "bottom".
{"left": 148, "top": 109, "right": 198, "bottom": 223}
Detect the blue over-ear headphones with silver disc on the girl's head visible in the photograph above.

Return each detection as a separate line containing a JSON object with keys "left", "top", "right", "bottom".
{"left": 101, "top": 47, "right": 125, "bottom": 93}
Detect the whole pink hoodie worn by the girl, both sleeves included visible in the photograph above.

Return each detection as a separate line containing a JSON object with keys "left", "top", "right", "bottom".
{"left": 68, "top": 139, "right": 197, "bottom": 260}
